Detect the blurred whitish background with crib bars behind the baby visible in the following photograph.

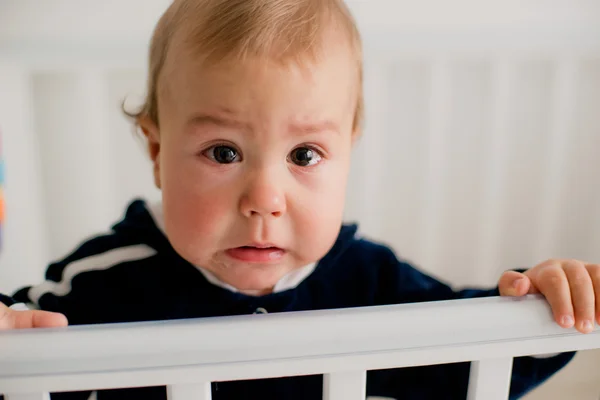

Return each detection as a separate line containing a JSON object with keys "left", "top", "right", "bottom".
{"left": 0, "top": 0, "right": 600, "bottom": 400}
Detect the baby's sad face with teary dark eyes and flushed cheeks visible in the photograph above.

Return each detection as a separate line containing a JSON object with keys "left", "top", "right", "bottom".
{"left": 142, "top": 42, "right": 358, "bottom": 294}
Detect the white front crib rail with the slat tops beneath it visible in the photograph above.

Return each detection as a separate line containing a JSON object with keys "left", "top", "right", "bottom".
{"left": 0, "top": 296, "right": 600, "bottom": 400}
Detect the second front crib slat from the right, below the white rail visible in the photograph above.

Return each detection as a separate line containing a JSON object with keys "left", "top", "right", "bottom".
{"left": 323, "top": 371, "right": 367, "bottom": 400}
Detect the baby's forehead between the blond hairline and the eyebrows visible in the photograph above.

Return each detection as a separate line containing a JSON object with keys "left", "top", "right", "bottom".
{"left": 159, "top": 46, "right": 358, "bottom": 136}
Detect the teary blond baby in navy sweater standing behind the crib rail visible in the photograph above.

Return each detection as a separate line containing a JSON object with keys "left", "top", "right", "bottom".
{"left": 0, "top": 0, "right": 600, "bottom": 400}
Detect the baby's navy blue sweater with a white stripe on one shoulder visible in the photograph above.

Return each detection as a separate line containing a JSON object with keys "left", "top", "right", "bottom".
{"left": 4, "top": 200, "right": 573, "bottom": 400}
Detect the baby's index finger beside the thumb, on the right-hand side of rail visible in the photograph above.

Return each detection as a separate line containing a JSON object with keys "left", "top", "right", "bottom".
{"left": 536, "top": 265, "right": 575, "bottom": 328}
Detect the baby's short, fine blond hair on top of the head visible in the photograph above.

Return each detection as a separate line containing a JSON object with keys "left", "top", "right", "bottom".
{"left": 125, "top": 0, "right": 364, "bottom": 132}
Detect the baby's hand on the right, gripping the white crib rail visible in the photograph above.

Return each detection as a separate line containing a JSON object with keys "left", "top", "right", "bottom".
{"left": 499, "top": 260, "right": 600, "bottom": 333}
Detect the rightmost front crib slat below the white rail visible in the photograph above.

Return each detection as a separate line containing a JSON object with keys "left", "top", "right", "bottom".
{"left": 467, "top": 358, "right": 513, "bottom": 400}
